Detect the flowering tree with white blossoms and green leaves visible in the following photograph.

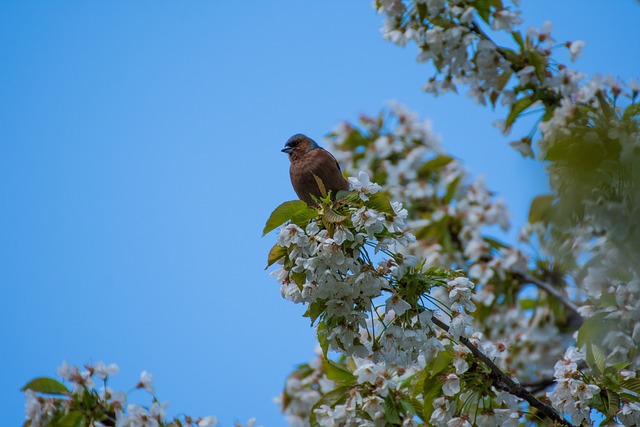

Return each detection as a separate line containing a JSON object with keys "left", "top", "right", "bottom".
{"left": 20, "top": 0, "right": 640, "bottom": 427}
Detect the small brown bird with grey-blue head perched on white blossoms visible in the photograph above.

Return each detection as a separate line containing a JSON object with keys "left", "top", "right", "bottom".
{"left": 281, "top": 133, "right": 349, "bottom": 205}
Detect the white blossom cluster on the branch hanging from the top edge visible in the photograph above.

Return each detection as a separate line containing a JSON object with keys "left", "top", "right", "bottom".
{"left": 374, "top": 0, "right": 640, "bottom": 165}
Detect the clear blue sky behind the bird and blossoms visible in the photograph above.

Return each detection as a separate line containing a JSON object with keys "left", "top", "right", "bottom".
{"left": 0, "top": 0, "right": 640, "bottom": 426}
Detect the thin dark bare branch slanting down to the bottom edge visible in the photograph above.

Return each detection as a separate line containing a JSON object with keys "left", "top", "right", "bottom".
{"left": 431, "top": 316, "right": 571, "bottom": 426}
